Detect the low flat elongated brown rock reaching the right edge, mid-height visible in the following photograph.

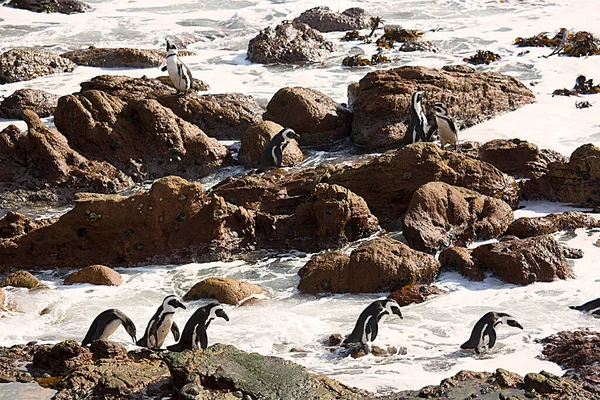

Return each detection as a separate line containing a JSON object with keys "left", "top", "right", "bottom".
{"left": 506, "top": 211, "right": 600, "bottom": 238}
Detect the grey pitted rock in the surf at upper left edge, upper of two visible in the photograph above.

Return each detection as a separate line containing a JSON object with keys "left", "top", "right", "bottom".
{"left": 0, "top": 49, "right": 77, "bottom": 84}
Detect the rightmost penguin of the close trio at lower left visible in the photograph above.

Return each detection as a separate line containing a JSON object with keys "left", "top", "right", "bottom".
{"left": 167, "top": 303, "right": 229, "bottom": 351}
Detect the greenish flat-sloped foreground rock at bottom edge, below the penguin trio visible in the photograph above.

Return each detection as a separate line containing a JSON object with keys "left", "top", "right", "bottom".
{"left": 164, "top": 344, "right": 370, "bottom": 400}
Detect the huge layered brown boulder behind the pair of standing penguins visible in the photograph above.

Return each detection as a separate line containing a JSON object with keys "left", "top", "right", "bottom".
{"left": 348, "top": 66, "right": 535, "bottom": 150}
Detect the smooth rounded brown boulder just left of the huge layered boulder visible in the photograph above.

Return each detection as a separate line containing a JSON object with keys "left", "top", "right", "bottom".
{"left": 264, "top": 87, "right": 352, "bottom": 146}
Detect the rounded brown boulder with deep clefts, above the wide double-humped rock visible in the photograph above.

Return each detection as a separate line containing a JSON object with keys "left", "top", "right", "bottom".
{"left": 402, "top": 182, "right": 513, "bottom": 253}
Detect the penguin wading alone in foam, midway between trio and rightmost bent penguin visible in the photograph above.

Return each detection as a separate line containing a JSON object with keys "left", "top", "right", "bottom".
{"left": 343, "top": 299, "right": 404, "bottom": 354}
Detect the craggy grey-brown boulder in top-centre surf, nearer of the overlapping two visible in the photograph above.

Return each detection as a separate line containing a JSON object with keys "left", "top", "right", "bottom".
{"left": 248, "top": 21, "right": 334, "bottom": 64}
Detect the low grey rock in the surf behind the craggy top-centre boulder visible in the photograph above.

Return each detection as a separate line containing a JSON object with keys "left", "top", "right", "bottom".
{"left": 294, "top": 7, "right": 371, "bottom": 32}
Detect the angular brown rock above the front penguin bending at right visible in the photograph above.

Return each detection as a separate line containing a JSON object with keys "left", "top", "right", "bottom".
{"left": 473, "top": 235, "right": 572, "bottom": 285}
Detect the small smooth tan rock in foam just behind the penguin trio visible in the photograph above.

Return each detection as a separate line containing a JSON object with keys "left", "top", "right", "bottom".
{"left": 183, "top": 277, "right": 267, "bottom": 305}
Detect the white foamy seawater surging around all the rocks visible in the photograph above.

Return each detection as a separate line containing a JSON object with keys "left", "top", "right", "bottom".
{"left": 0, "top": 0, "right": 600, "bottom": 398}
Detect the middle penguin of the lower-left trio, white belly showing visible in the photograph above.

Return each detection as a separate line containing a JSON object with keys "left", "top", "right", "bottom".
{"left": 136, "top": 295, "right": 185, "bottom": 349}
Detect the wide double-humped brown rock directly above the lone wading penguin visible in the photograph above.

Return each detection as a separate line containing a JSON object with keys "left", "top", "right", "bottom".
{"left": 298, "top": 237, "right": 439, "bottom": 293}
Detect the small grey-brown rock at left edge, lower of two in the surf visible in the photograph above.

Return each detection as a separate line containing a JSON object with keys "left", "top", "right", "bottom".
{"left": 0, "top": 89, "right": 58, "bottom": 119}
